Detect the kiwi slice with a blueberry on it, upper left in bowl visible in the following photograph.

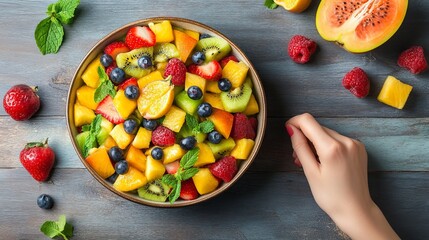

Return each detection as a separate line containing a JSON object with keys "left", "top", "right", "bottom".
{"left": 116, "top": 47, "right": 153, "bottom": 78}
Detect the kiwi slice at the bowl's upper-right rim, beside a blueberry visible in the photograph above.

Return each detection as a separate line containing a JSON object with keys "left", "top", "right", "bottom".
{"left": 196, "top": 37, "right": 231, "bottom": 62}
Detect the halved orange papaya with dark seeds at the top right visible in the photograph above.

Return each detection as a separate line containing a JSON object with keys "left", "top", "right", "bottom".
{"left": 316, "top": 0, "right": 408, "bottom": 53}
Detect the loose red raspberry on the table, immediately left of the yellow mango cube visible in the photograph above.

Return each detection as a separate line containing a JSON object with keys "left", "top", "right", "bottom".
{"left": 343, "top": 67, "right": 370, "bottom": 98}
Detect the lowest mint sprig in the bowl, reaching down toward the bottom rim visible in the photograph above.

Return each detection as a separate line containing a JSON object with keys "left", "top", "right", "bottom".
{"left": 162, "top": 147, "right": 200, "bottom": 203}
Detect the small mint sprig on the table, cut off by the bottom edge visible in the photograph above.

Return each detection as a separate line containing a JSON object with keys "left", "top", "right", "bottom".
{"left": 40, "top": 215, "right": 73, "bottom": 240}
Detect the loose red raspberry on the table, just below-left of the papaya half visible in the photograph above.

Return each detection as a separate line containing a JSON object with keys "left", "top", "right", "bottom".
{"left": 287, "top": 35, "right": 317, "bottom": 64}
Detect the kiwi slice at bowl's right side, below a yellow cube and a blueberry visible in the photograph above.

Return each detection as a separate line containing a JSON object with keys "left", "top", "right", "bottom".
{"left": 220, "top": 84, "right": 252, "bottom": 112}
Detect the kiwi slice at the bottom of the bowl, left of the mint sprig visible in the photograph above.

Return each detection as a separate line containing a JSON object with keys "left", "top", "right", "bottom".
{"left": 137, "top": 179, "right": 170, "bottom": 202}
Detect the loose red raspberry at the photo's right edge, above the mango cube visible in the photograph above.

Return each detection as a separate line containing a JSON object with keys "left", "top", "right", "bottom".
{"left": 398, "top": 46, "right": 428, "bottom": 74}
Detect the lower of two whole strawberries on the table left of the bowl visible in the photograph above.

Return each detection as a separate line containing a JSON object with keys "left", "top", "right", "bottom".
{"left": 19, "top": 139, "right": 55, "bottom": 182}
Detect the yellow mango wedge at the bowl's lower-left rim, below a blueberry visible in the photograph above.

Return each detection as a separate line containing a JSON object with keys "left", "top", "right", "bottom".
{"left": 113, "top": 166, "right": 148, "bottom": 192}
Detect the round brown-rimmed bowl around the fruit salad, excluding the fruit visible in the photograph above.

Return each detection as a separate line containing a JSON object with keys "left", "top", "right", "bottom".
{"left": 66, "top": 17, "right": 266, "bottom": 207}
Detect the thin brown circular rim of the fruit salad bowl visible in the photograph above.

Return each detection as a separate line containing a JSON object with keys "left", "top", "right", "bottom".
{"left": 66, "top": 16, "right": 267, "bottom": 208}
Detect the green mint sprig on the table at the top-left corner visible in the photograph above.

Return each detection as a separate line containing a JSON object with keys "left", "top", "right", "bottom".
{"left": 34, "top": 0, "right": 80, "bottom": 55}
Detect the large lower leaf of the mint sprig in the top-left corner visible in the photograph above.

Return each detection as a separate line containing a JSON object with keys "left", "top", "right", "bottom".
{"left": 34, "top": 17, "right": 64, "bottom": 55}
